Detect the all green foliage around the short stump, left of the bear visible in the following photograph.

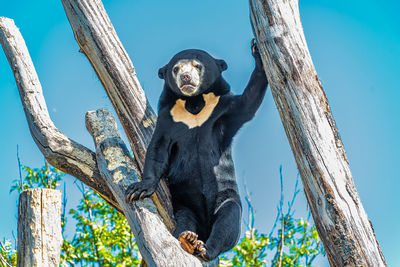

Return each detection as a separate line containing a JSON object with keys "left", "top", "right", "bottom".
{"left": 0, "top": 162, "right": 141, "bottom": 266}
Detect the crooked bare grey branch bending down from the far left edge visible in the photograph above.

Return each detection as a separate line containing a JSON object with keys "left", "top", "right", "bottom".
{"left": 0, "top": 17, "right": 121, "bottom": 214}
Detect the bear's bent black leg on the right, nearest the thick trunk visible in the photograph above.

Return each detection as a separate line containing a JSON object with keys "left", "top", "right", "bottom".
{"left": 200, "top": 201, "right": 242, "bottom": 260}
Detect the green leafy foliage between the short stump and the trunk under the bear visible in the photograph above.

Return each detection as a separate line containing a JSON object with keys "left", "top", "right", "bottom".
{"left": 62, "top": 185, "right": 141, "bottom": 266}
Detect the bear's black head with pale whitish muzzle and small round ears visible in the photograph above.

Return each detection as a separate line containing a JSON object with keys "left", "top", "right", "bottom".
{"left": 158, "top": 49, "right": 228, "bottom": 97}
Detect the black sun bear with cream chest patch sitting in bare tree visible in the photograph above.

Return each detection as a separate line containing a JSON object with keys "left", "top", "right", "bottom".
{"left": 126, "top": 40, "right": 268, "bottom": 261}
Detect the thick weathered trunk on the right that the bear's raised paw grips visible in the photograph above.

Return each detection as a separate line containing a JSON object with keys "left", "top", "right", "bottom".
{"left": 249, "top": 0, "right": 386, "bottom": 266}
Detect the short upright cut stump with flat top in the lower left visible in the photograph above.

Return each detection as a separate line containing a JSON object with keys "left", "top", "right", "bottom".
{"left": 17, "top": 188, "right": 63, "bottom": 267}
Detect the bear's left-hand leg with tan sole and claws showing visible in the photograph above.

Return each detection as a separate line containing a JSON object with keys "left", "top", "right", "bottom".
{"left": 174, "top": 206, "right": 202, "bottom": 254}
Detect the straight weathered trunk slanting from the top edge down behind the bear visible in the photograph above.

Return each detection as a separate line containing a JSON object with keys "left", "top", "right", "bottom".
{"left": 62, "top": 0, "right": 174, "bottom": 230}
